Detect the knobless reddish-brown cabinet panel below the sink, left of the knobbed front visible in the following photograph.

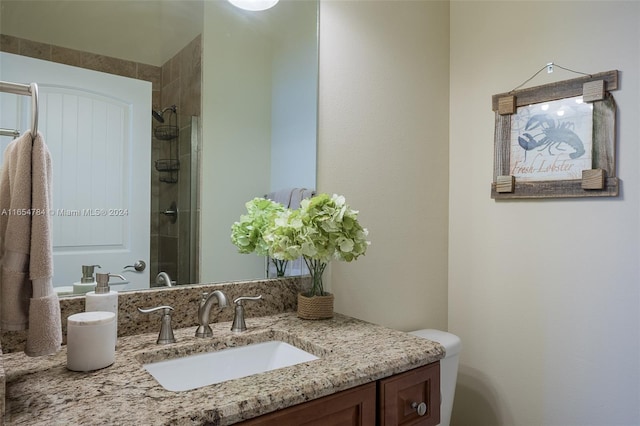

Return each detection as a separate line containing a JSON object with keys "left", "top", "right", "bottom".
{"left": 240, "top": 383, "right": 376, "bottom": 426}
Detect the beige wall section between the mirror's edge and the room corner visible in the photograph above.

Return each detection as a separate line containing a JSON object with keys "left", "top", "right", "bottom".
{"left": 318, "top": 1, "right": 449, "bottom": 332}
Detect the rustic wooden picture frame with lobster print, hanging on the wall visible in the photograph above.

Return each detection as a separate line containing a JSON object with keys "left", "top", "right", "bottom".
{"left": 491, "top": 70, "right": 620, "bottom": 200}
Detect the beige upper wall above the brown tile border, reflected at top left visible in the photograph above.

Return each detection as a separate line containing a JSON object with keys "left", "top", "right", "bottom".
{"left": 0, "top": 0, "right": 204, "bottom": 66}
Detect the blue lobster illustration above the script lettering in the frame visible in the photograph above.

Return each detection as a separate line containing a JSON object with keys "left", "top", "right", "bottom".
{"left": 518, "top": 114, "right": 585, "bottom": 159}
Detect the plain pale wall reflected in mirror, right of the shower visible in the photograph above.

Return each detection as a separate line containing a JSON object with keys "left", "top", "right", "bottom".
{"left": 200, "top": 1, "right": 317, "bottom": 282}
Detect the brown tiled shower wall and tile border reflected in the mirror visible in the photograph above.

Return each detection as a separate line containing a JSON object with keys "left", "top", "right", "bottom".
{"left": 0, "top": 34, "right": 202, "bottom": 284}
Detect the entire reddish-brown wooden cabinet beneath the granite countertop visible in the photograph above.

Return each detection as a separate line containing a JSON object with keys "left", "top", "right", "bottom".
{"left": 239, "top": 362, "right": 440, "bottom": 426}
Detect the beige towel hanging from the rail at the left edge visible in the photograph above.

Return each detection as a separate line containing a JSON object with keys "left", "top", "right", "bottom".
{"left": 0, "top": 131, "right": 62, "bottom": 356}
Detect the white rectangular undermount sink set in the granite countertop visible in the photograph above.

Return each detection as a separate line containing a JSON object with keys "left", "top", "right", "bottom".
{"left": 143, "top": 340, "right": 318, "bottom": 391}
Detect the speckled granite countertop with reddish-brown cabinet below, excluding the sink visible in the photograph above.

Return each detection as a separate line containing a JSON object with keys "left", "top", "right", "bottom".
{"left": 2, "top": 280, "right": 444, "bottom": 426}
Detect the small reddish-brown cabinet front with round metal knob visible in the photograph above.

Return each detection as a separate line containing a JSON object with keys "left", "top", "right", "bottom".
{"left": 379, "top": 362, "right": 440, "bottom": 426}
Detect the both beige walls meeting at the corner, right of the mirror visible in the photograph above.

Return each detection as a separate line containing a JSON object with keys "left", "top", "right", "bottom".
{"left": 318, "top": 1, "right": 640, "bottom": 426}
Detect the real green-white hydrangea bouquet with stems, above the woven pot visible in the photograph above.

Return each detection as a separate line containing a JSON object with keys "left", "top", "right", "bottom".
{"left": 263, "top": 194, "right": 370, "bottom": 296}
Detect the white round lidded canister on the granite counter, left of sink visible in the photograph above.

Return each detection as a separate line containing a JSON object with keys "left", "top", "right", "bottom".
{"left": 67, "top": 311, "right": 116, "bottom": 371}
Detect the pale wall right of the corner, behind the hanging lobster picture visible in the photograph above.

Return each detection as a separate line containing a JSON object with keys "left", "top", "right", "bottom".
{"left": 449, "top": 1, "right": 640, "bottom": 426}
